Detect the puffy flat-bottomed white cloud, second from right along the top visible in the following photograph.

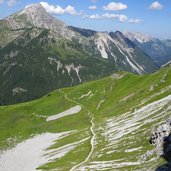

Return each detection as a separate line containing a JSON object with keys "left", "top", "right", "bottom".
{"left": 103, "top": 2, "right": 128, "bottom": 11}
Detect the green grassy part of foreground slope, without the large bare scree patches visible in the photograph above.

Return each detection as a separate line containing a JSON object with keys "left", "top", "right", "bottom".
{"left": 0, "top": 66, "right": 171, "bottom": 171}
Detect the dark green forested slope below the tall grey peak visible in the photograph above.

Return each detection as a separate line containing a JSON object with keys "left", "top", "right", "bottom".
{"left": 0, "top": 28, "right": 116, "bottom": 104}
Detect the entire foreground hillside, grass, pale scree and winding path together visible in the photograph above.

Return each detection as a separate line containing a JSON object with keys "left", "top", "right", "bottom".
{"left": 0, "top": 64, "right": 171, "bottom": 171}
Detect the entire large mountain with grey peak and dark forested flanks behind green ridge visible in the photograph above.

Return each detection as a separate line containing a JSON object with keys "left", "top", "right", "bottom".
{"left": 0, "top": 4, "right": 157, "bottom": 105}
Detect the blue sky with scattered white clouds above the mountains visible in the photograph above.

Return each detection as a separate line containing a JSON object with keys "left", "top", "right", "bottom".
{"left": 0, "top": 0, "right": 171, "bottom": 39}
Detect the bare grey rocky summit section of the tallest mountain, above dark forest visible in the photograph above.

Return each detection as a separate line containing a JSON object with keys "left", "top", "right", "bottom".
{"left": 0, "top": 4, "right": 75, "bottom": 46}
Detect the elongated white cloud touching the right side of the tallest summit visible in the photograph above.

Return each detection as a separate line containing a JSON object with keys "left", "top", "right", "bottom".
{"left": 40, "top": 2, "right": 80, "bottom": 15}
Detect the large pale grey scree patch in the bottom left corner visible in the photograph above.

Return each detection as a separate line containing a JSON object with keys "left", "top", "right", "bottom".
{"left": 0, "top": 131, "right": 72, "bottom": 171}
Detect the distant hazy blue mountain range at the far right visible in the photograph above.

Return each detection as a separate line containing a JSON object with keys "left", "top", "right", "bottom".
{"left": 124, "top": 31, "right": 171, "bottom": 66}
